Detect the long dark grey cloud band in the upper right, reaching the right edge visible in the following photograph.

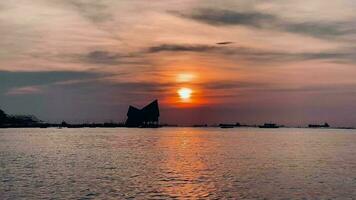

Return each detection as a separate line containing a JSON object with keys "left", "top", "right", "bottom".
{"left": 174, "top": 9, "right": 356, "bottom": 39}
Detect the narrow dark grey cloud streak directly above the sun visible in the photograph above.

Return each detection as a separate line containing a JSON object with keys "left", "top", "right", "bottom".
{"left": 147, "top": 44, "right": 218, "bottom": 53}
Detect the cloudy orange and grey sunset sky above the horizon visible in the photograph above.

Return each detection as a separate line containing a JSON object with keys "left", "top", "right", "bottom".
{"left": 0, "top": 0, "right": 356, "bottom": 126}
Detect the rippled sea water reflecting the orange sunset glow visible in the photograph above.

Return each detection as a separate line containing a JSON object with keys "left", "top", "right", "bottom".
{"left": 0, "top": 128, "right": 356, "bottom": 199}
